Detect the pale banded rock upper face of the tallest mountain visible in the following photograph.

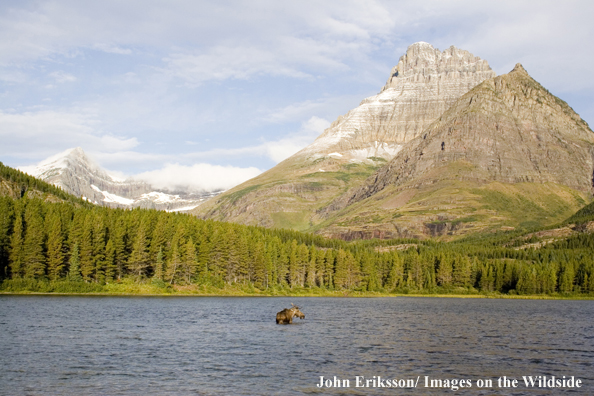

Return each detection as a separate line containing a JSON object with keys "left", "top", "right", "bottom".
{"left": 301, "top": 42, "right": 495, "bottom": 161}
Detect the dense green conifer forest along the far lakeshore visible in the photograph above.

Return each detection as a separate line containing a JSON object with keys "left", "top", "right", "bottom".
{"left": 0, "top": 162, "right": 594, "bottom": 295}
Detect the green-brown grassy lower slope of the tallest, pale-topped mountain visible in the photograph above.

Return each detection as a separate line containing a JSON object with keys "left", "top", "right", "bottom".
{"left": 193, "top": 157, "right": 384, "bottom": 231}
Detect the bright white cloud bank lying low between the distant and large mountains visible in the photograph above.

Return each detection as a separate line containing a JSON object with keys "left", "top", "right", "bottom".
{"left": 134, "top": 163, "right": 262, "bottom": 191}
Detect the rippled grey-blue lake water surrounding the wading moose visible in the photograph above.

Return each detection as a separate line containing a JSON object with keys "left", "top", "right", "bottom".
{"left": 0, "top": 296, "right": 594, "bottom": 395}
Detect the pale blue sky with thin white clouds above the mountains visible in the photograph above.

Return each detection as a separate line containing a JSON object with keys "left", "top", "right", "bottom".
{"left": 0, "top": 0, "right": 594, "bottom": 190}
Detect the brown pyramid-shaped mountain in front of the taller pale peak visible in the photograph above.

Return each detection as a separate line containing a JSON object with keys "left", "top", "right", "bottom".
{"left": 320, "top": 64, "right": 594, "bottom": 239}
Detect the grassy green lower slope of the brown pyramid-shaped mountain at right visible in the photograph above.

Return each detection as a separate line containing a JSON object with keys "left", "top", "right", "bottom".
{"left": 315, "top": 159, "right": 591, "bottom": 239}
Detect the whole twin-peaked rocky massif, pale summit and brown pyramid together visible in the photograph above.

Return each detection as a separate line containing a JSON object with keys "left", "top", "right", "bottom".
{"left": 194, "top": 42, "right": 594, "bottom": 239}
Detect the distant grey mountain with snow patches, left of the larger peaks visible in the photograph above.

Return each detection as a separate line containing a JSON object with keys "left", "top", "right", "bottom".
{"left": 21, "top": 147, "right": 218, "bottom": 211}
